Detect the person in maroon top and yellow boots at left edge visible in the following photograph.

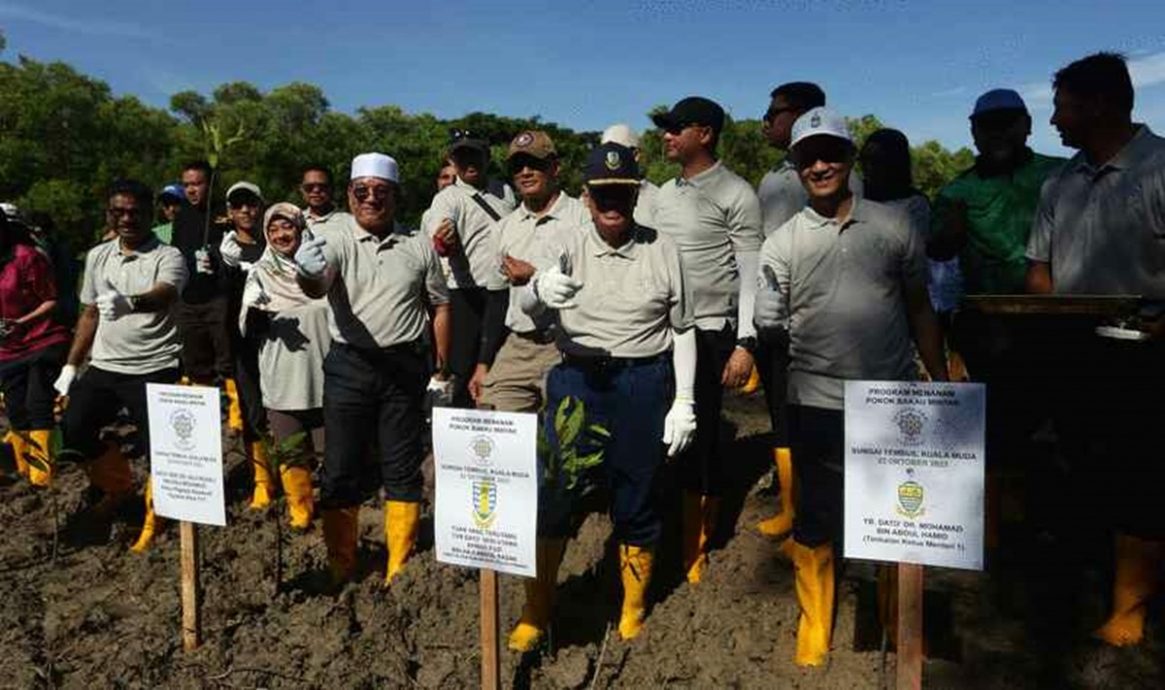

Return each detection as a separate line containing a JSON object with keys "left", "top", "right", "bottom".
{"left": 0, "top": 212, "right": 69, "bottom": 486}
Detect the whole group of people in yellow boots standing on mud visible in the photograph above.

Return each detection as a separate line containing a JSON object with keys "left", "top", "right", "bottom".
{"left": 0, "top": 47, "right": 1165, "bottom": 666}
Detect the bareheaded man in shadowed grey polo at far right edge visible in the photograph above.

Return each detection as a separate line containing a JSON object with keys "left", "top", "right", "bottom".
{"left": 1028, "top": 52, "right": 1165, "bottom": 646}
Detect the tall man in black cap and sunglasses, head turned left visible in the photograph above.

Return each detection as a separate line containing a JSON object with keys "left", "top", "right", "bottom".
{"left": 652, "top": 97, "right": 764, "bottom": 583}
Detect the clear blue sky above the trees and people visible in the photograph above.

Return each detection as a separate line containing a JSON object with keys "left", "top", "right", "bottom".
{"left": 0, "top": 0, "right": 1165, "bottom": 153}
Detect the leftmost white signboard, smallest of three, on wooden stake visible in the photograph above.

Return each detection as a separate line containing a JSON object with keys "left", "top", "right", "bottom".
{"left": 146, "top": 383, "right": 226, "bottom": 527}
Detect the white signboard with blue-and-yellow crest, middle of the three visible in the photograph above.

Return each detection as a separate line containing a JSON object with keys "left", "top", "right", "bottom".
{"left": 432, "top": 407, "right": 538, "bottom": 577}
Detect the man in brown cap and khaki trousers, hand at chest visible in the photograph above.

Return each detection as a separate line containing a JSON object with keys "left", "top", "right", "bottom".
{"left": 469, "top": 131, "right": 591, "bottom": 413}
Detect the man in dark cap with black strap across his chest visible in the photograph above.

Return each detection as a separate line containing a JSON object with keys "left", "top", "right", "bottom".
{"left": 422, "top": 131, "right": 515, "bottom": 407}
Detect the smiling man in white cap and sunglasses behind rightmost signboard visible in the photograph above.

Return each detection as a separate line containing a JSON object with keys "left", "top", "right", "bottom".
{"left": 755, "top": 107, "right": 947, "bottom": 666}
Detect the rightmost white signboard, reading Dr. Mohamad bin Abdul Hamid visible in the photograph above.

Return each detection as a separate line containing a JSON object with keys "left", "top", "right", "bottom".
{"left": 845, "top": 381, "right": 987, "bottom": 570}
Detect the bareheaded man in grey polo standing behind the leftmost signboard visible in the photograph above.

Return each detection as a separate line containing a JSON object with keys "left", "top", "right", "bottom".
{"left": 54, "top": 181, "right": 186, "bottom": 531}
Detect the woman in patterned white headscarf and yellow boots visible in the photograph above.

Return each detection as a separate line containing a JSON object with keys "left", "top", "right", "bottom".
{"left": 239, "top": 203, "right": 332, "bottom": 529}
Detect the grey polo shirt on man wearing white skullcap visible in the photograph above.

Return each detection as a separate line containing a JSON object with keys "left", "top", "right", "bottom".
{"left": 319, "top": 217, "right": 449, "bottom": 348}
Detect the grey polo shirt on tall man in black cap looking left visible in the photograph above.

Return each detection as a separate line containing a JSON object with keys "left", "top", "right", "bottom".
{"left": 655, "top": 162, "right": 764, "bottom": 336}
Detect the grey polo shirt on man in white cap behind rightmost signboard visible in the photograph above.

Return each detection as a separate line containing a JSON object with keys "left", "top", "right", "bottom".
{"left": 761, "top": 199, "right": 926, "bottom": 409}
